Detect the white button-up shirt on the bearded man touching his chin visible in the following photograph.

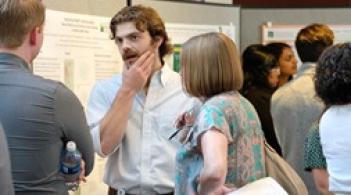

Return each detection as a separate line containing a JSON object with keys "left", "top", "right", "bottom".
{"left": 87, "top": 65, "right": 197, "bottom": 195}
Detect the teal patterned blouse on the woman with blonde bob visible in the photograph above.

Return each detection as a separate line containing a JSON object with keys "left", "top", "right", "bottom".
{"left": 175, "top": 92, "right": 266, "bottom": 195}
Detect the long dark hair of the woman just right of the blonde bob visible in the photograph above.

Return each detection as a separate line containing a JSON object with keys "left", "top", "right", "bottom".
{"left": 242, "top": 44, "right": 278, "bottom": 94}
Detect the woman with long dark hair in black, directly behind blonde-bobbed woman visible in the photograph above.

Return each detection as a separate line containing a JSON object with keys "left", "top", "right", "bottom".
{"left": 241, "top": 44, "right": 282, "bottom": 155}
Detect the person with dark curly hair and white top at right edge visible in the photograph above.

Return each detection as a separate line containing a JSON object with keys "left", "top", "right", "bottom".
{"left": 314, "top": 43, "right": 351, "bottom": 194}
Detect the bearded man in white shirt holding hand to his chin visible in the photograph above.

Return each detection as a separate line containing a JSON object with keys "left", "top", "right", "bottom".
{"left": 87, "top": 5, "right": 193, "bottom": 194}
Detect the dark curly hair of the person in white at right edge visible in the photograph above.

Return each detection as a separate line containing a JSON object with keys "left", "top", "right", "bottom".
{"left": 315, "top": 43, "right": 351, "bottom": 106}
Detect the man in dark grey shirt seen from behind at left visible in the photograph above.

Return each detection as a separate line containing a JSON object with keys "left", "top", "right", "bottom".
{"left": 0, "top": 0, "right": 94, "bottom": 195}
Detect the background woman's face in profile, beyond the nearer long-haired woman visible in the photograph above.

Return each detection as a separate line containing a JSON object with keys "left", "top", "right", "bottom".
{"left": 267, "top": 42, "right": 297, "bottom": 87}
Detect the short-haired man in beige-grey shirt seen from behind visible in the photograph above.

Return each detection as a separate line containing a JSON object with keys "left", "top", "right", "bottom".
{"left": 271, "top": 24, "right": 334, "bottom": 194}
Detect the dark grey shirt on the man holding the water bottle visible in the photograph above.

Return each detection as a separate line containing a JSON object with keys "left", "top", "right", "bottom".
{"left": 0, "top": 53, "right": 94, "bottom": 195}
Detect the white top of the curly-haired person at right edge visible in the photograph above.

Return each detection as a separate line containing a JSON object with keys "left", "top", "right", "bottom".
{"left": 319, "top": 104, "right": 351, "bottom": 194}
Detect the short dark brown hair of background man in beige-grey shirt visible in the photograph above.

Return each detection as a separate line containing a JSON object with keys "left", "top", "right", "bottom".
{"left": 295, "top": 24, "right": 334, "bottom": 62}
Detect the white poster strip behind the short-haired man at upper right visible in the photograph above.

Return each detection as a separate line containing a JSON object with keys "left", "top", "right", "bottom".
{"left": 262, "top": 22, "right": 351, "bottom": 46}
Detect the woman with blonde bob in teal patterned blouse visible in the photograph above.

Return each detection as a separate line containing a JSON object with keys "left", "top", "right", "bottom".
{"left": 175, "top": 33, "right": 266, "bottom": 194}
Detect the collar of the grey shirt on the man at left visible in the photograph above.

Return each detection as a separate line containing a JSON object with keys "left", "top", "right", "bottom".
{"left": 0, "top": 53, "right": 32, "bottom": 72}
